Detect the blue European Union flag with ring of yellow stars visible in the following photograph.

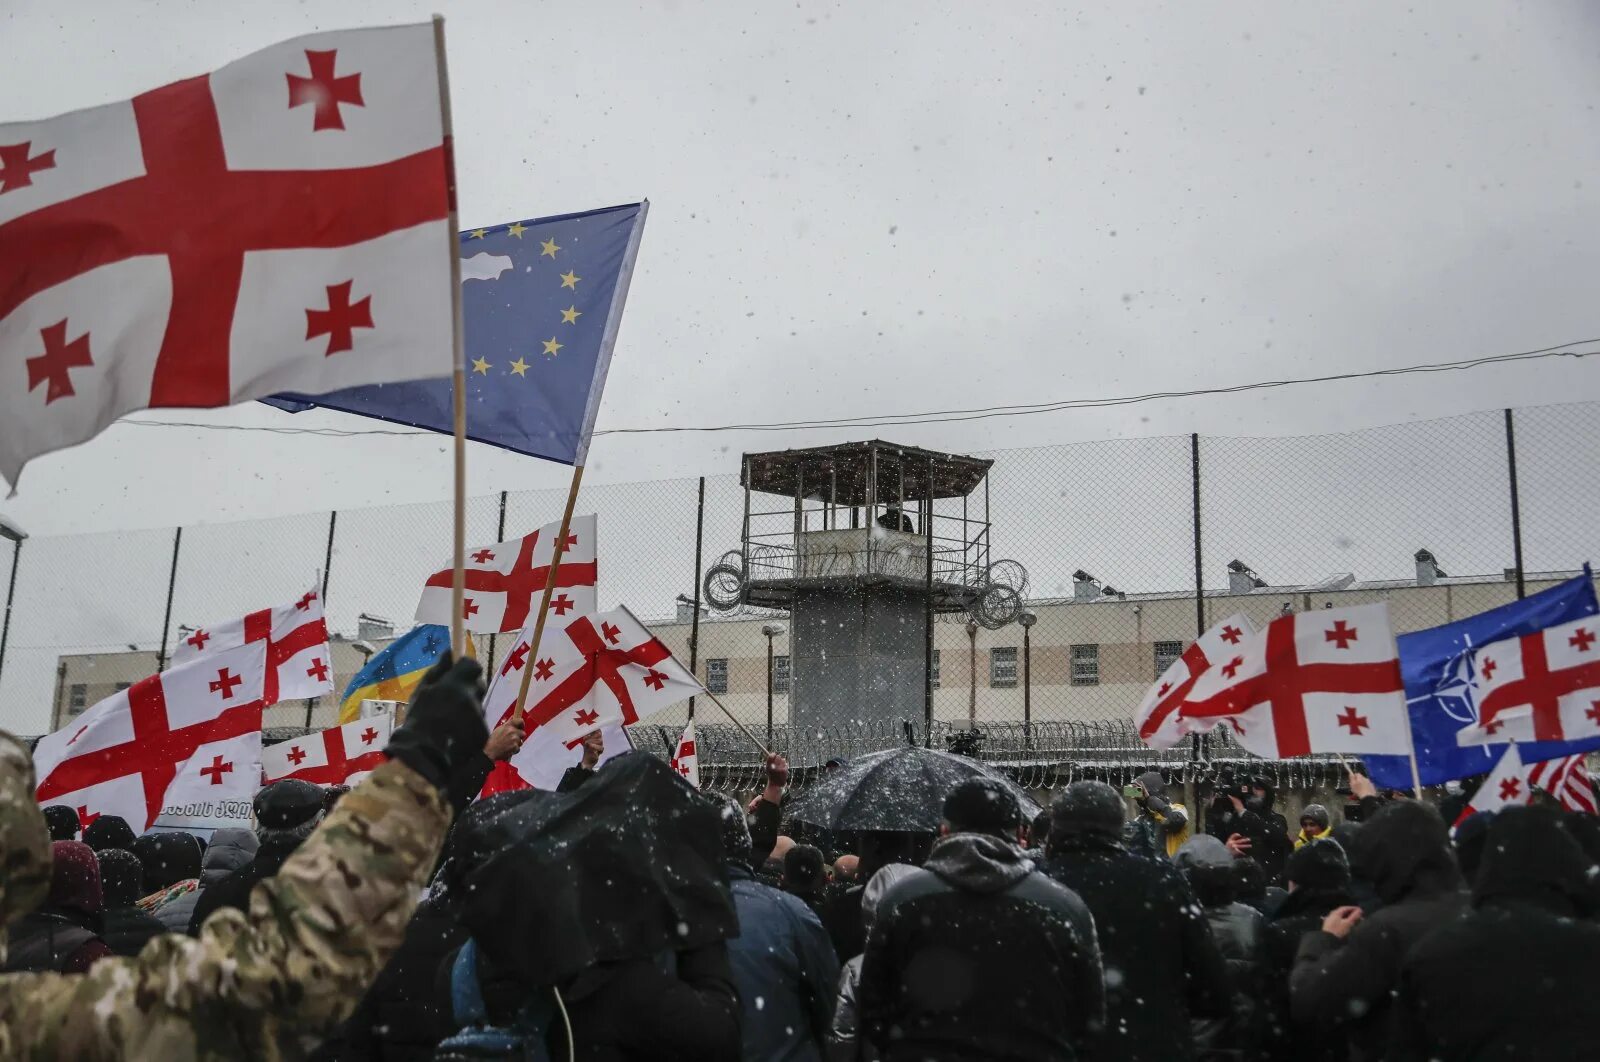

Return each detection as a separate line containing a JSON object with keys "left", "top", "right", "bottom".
{"left": 264, "top": 203, "right": 650, "bottom": 464}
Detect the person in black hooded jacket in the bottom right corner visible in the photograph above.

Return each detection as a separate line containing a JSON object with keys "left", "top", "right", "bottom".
{"left": 1386, "top": 808, "right": 1600, "bottom": 1062}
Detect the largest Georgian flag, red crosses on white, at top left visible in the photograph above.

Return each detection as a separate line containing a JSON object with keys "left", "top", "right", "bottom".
{"left": 0, "top": 24, "right": 456, "bottom": 486}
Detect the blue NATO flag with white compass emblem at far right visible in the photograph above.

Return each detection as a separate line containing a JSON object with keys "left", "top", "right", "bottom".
{"left": 1362, "top": 568, "right": 1600, "bottom": 789}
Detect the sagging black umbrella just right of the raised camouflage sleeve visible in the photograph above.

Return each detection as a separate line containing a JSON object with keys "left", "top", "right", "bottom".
{"left": 459, "top": 752, "right": 739, "bottom": 985}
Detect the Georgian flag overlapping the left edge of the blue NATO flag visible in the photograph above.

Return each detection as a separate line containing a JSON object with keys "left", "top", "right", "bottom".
{"left": 1179, "top": 603, "right": 1411, "bottom": 758}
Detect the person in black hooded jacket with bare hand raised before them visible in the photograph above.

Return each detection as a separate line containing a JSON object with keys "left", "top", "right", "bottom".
{"left": 1290, "top": 800, "right": 1467, "bottom": 1062}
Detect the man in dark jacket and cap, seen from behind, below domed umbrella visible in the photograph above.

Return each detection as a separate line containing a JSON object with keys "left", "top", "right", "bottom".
{"left": 859, "top": 779, "right": 1104, "bottom": 1062}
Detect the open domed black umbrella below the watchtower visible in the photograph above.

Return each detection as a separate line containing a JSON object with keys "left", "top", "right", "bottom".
{"left": 784, "top": 745, "right": 1038, "bottom": 833}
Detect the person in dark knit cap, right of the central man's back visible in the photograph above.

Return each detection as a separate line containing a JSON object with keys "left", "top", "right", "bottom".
{"left": 1045, "top": 782, "right": 1229, "bottom": 1062}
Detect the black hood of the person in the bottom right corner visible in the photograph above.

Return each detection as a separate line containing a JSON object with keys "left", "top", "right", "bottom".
{"left": 1472, "top": 808, "right": 1600, "bottom": 918}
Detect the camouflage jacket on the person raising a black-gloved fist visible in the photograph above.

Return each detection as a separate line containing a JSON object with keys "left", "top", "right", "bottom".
{"left": 0, "top": 733, "right": 450, "bottom": 1062}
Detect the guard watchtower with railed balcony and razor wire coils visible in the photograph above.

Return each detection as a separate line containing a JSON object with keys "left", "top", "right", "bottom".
{"left": 706, "top": 441, "right": 992, "bottom": 726}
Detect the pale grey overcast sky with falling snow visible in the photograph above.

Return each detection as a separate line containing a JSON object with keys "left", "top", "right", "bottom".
{"left": 0, "top": 0, "right": 1600, "bottom": 536}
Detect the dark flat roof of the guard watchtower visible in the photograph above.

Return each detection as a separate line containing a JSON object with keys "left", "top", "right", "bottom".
{"left": 739, "top": 440, "right": 994, "bottom": 505}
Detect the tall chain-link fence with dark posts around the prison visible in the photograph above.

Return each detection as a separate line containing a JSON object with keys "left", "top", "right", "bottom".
{"left": 0, "top": 403, "right": 1600, "bottom": 785}
